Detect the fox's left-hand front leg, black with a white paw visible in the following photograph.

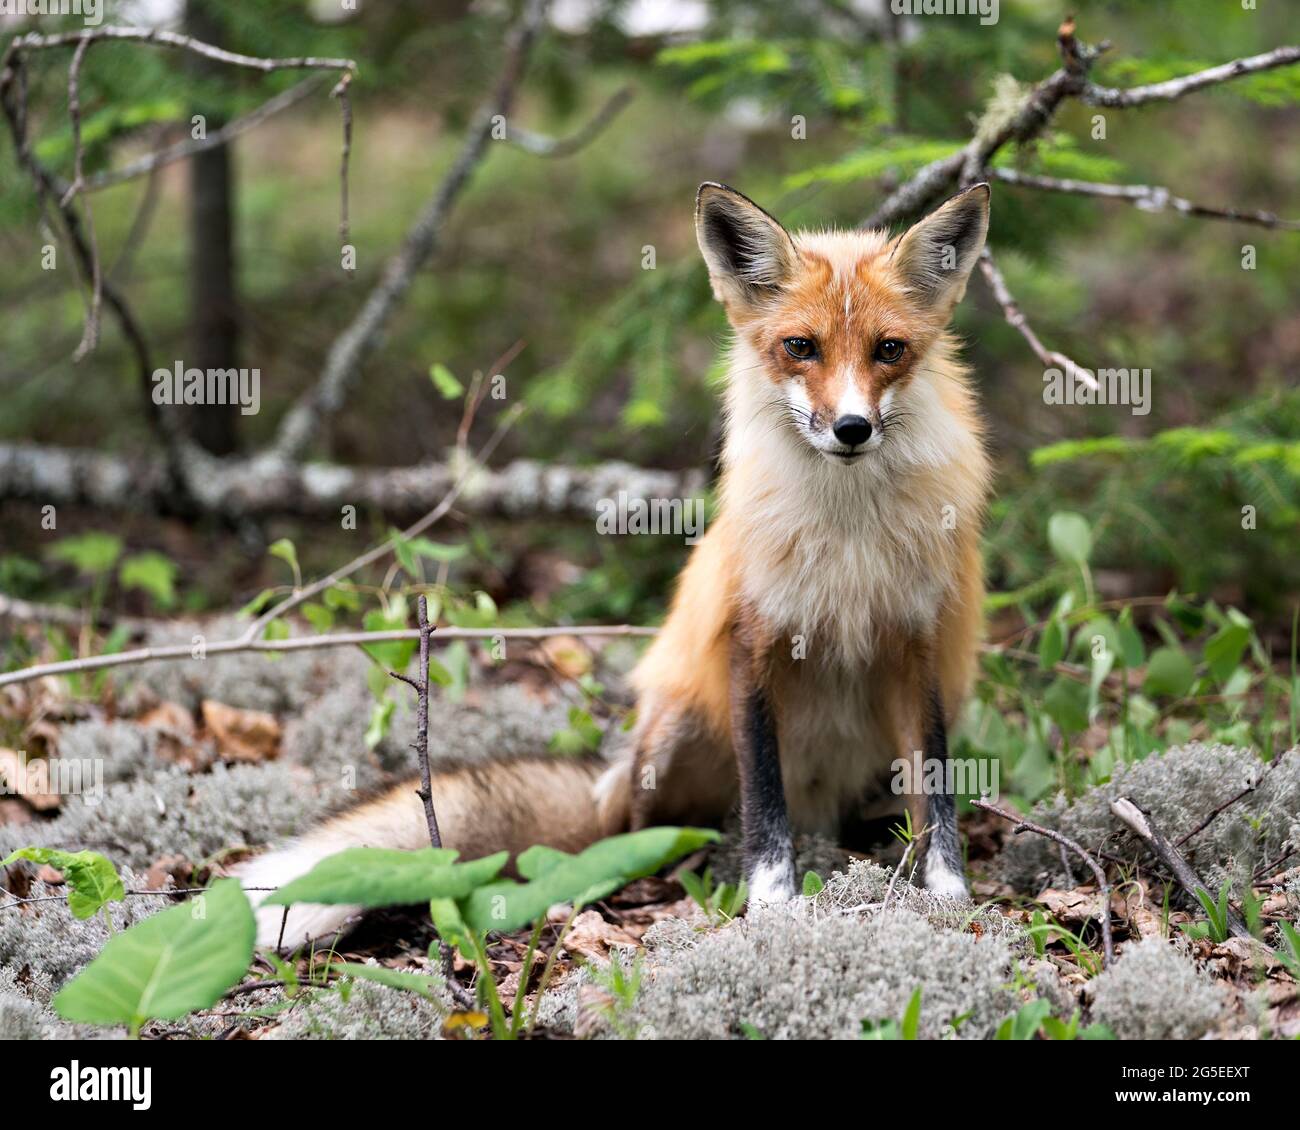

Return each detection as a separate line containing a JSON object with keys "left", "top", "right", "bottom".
{"left": 731, "top": 616, "right": 797, "bottom": 902}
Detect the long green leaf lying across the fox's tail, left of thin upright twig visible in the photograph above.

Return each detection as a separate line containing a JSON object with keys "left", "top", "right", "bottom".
{"left": 267, "top": 848, "right": 510, "bottom": 906}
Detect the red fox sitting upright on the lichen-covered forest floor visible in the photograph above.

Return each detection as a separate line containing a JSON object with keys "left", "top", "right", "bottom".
{"left": 242, "top": 182, "right": 991, "bottom": 947}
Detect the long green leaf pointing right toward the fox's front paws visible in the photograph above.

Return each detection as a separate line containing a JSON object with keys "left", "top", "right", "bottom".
{"left": 462, "top": 827, "right": 720, "bottom": 931}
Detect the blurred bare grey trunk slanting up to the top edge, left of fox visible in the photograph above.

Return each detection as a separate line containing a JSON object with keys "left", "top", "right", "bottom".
{"left": 273, "top": 0, "right": 547, "bottom": 460}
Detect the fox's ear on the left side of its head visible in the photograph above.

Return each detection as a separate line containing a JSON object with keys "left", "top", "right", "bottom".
{"left": 696, "top": 181, "right": 797, "bottom": 306}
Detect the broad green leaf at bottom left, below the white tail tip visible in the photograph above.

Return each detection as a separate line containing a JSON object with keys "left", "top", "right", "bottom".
{"left": 53, "top": 879, "right": 257, "bottom": 1029}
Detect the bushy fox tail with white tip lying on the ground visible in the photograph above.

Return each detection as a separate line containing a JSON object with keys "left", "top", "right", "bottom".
{"left": 238, "top": 757, "right": 627, "bottom": 951}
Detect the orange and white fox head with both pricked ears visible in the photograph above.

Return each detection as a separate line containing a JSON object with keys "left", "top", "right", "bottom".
{"left": 696, "top": 182, "right": 989, "bottom": 466}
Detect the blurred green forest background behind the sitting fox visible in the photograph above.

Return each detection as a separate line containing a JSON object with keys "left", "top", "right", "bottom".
{"left": 0, "top": 0, "right": 1300, "bottom": 800}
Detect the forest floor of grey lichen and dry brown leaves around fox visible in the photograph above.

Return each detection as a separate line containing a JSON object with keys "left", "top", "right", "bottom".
{"left": 0, "top": 623, "right": 1300, "bottom": 1039}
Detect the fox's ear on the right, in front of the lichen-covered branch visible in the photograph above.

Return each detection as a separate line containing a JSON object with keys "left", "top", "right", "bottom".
{"left": 893, "top": 185, "right": 989, "bottom": 312}
